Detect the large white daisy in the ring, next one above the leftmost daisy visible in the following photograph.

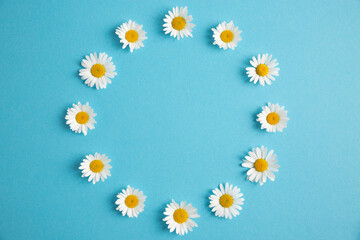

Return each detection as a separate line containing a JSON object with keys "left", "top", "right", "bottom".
{"left": 79, "top": 53, "right": 117, "bottom": 90}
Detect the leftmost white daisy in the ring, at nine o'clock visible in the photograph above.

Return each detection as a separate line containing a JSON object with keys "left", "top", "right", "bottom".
{"left": 65, "top": 102, "right": 96, "bottom": 136}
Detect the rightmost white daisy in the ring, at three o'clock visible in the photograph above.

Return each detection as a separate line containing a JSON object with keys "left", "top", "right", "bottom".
{"left": 256, "top": 103, "right": 289, "bottom": 132}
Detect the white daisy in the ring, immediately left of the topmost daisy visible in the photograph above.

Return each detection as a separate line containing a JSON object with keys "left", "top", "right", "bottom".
{"left": 115, "top": 20, "right": 147, "bottom": 52}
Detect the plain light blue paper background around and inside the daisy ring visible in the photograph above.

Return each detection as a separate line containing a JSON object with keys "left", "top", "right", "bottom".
{"left": 0, "top": 0, "right": 360, "bottom": 240}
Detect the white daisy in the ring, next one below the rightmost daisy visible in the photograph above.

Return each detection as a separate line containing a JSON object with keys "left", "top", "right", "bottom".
{"left": 241, "top": 146, "right": 280, "bottom": 186}
